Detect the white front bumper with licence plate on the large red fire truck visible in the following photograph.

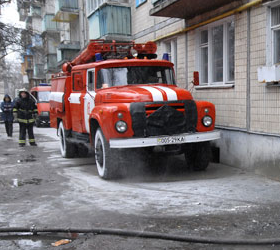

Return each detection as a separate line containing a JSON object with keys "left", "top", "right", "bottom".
{"left": 109, "top": 130, "right": 221, "bottom": 148}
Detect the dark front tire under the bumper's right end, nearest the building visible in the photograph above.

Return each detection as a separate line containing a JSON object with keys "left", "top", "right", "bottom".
{"left": 185, "top": 142, "right": 211, "bottom": 171}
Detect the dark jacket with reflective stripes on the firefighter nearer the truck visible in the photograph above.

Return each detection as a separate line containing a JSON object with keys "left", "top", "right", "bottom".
{"left": 13, "top": 93, "right": 38, "bottom": 124}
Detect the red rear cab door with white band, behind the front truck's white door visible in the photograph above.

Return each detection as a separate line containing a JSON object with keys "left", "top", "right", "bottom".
{"left": 68, "top": 72, "right": 85, "bottom": 133}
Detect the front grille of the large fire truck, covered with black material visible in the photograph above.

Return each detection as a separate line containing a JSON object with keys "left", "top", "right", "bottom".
{"left": 130, "top": 100, "right": 197, "bottom": 137}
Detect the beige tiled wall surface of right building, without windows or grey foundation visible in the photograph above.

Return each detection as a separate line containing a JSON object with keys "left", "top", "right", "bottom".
{"left": 132, "top": 1, "right": 280, "bottom": 134}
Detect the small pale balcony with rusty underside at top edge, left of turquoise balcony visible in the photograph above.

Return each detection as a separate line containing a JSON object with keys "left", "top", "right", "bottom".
{"left": 54, "top": 0, "right": 79, "bottom": 22}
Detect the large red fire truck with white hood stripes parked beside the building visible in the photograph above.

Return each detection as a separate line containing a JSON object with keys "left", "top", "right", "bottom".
{"left": 50, "top": 40, "right": 220, "bottom": 179}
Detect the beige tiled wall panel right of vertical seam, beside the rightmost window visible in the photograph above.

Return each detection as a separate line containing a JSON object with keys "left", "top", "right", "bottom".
{"left": 250, "top": 7, "right": 280, "bottom": 134}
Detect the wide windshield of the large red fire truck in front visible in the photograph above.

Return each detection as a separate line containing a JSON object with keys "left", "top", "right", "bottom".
{"left": 97, "top": 66, "right": 175, "bottom": 89}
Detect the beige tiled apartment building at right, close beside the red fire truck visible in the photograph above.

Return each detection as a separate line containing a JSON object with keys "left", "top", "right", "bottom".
{"left": 131, "top": 0, "right": 280, "bottom": 172}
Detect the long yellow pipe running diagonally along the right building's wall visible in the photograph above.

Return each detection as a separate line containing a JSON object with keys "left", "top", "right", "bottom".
{"left": 153, "top": 0, "right": 265, "bottom": 42}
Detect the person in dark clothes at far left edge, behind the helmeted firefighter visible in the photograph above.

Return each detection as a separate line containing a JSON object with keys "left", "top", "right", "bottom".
{"left": 1, "top": 95, "right": 14, "bottom": 137}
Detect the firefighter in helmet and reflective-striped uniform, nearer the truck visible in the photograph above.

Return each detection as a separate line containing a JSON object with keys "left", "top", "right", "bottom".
{"left": 13, "top": 89, "right": 38, "bottom": 147}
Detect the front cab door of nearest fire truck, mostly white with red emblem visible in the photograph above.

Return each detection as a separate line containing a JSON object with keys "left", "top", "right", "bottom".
{"left": 84, "top": 69, "right": 96, "bottom": 133}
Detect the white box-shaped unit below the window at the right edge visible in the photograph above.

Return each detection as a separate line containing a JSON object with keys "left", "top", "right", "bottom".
{"left": 258, "top": 65, "right": 280, "bottom": 83}
